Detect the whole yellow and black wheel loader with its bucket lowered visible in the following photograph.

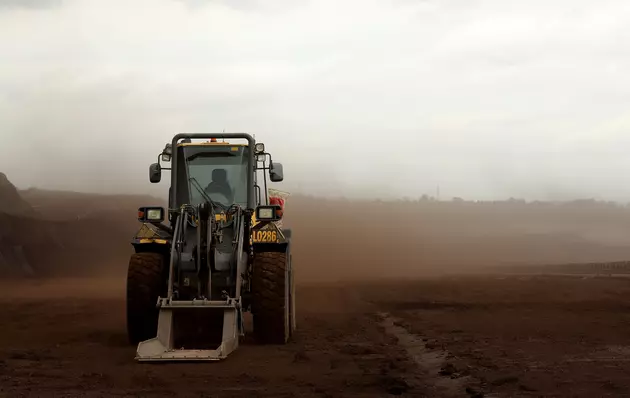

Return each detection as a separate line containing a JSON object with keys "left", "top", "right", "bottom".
{"left": 127, "top": 133, "right": 296, "bottom": 361}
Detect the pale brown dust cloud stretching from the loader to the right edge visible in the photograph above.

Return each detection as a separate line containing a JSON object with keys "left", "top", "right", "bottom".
{"left": 285, "top": 197, "right": 630, "bottom": 282}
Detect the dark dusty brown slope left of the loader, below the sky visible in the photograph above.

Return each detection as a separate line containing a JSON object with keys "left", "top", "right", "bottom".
{"left": 0, "top": 180, "right": 162, "bottom": 276}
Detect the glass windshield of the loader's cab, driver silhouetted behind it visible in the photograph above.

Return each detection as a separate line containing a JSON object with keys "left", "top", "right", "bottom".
{"left": 177, "top": 145, "right": 248, "bottom": 207}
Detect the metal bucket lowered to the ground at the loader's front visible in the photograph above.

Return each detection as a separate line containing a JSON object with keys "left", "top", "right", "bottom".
{"left": 135, "top": 300, "right": 241, "bottom": 362}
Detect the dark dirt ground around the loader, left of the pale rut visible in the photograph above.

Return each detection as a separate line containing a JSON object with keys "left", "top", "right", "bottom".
{"left": 0, "top": 279, "right": 424, "bottom": 397}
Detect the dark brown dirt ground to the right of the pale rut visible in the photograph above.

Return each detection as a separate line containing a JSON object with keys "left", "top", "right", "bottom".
{"left": 364, "top": 275, "right": 630, "bottom": 397}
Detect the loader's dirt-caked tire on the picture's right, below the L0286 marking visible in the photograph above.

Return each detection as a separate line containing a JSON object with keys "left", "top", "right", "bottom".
{"left": 252, "top": 252, "right": 291, "bottom": 344}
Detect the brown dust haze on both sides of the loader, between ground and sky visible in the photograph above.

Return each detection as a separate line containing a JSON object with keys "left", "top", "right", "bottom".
{"left": 0, "top": 173, "right": 630, "bottom": 283}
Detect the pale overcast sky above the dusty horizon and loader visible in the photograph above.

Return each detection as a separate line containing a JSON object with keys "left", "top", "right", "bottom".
{"left": 0, "top": 0, "right": 630, "bottom": 201}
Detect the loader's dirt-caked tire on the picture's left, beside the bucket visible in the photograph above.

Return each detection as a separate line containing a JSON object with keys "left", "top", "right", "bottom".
{"left": 127, "top": 253, "right": 166, "bottom": 345}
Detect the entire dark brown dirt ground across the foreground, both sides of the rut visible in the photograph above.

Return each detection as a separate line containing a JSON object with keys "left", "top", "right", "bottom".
{"left": 0, "top": 275, "right": 630, "bottom": 397}
